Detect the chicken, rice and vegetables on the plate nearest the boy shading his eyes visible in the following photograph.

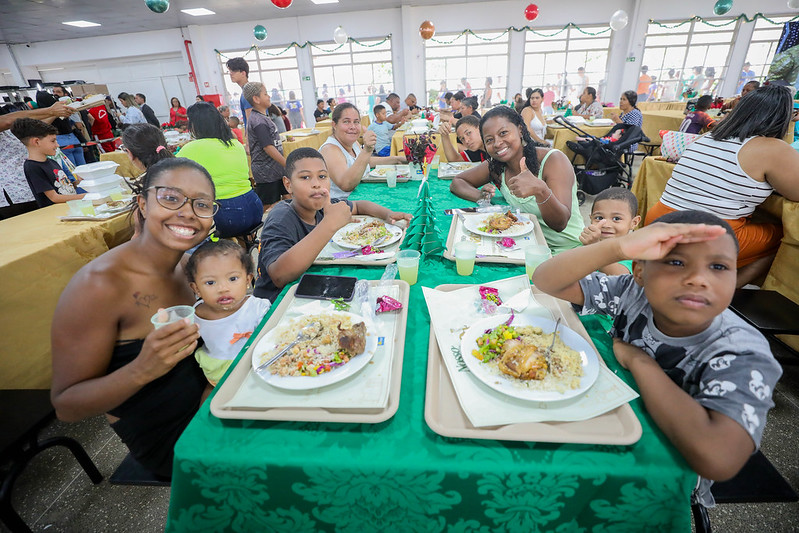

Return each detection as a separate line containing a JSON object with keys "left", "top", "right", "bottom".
{"left": 472, "top": 324, "right": 583, "bottom": 392}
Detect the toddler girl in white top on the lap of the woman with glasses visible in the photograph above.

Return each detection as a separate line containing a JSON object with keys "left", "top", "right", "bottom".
{"left": 186, "top": 240, "right": 271, "bottom": 386}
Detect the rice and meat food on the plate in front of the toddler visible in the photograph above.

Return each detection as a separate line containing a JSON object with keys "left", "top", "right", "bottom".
{"left": 261, "top": 313, "right": 366, "bottom": 377}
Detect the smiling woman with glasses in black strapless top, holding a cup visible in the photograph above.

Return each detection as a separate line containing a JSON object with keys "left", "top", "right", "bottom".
{"left": 51, "top": 158, "right": 218, "bottom": 479}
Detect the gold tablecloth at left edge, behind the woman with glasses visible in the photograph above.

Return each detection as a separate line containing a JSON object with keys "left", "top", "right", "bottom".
{"left": 0, "top": 204, "right": 133, "bottom": 389}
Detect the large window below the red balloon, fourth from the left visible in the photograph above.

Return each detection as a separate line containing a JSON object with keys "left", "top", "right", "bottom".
{"left": 522, "top": 26, "right": 610, "bottom": 104}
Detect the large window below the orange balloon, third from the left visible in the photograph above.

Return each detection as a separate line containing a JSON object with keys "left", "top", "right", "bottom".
{"left": 418, "top": 31, "right": 509, "bottom": 105}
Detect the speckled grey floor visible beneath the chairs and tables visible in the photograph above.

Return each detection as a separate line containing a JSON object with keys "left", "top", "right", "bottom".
{"left": 6, "top": 164, "right": 799, "bottom": 533}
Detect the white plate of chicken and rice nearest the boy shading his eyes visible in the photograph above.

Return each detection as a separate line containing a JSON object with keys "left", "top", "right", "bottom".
{"left": 461, "top": 314, "right": 599, "bottom": 402}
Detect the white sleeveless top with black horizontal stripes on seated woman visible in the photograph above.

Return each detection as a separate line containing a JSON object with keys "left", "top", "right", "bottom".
{"left": 660, "top": 134, "right": 774, "bottom": 220}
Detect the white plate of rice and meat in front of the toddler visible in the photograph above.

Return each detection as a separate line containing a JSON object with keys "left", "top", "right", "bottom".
{"left": 252, "top": 311, "right": 378, "bottom": 390}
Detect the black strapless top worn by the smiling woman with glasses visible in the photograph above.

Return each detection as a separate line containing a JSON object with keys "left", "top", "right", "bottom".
{"left": 108, "top": 339, "right": 208, "bottom": 477}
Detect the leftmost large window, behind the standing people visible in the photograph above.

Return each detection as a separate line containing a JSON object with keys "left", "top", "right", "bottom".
{"left": 219, "top": 46, "right": 307, "bottom": 115}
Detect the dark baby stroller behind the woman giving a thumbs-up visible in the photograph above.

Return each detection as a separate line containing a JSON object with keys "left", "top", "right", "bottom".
{"left": 555, "top": 117, "right": 649, "bottom": 204}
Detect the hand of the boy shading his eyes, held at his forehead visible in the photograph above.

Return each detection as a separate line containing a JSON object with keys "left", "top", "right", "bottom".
{"left": 614, "top": 223, "right": 726, "bottom": 260}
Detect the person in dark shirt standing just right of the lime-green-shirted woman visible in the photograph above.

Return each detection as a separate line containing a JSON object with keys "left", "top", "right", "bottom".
{"left": 242, "top": 81, "right": 286, "bottom": 211}
